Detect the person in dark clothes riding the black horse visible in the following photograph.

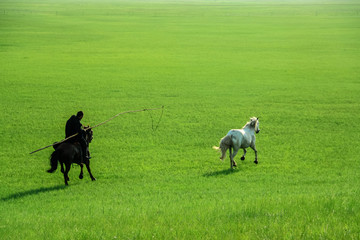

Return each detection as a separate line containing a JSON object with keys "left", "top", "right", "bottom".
{"left": 65, "top": 111, "right": 91, "bottom": 162}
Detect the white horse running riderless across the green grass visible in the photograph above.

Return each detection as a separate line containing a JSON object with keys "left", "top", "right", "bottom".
{"left": 213, "top": 117, "right": 260, "bottom": 168}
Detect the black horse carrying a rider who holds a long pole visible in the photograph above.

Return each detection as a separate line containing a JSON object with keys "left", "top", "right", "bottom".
{"left": 48, "top": 128, "right": 96, "bottom": 185}
